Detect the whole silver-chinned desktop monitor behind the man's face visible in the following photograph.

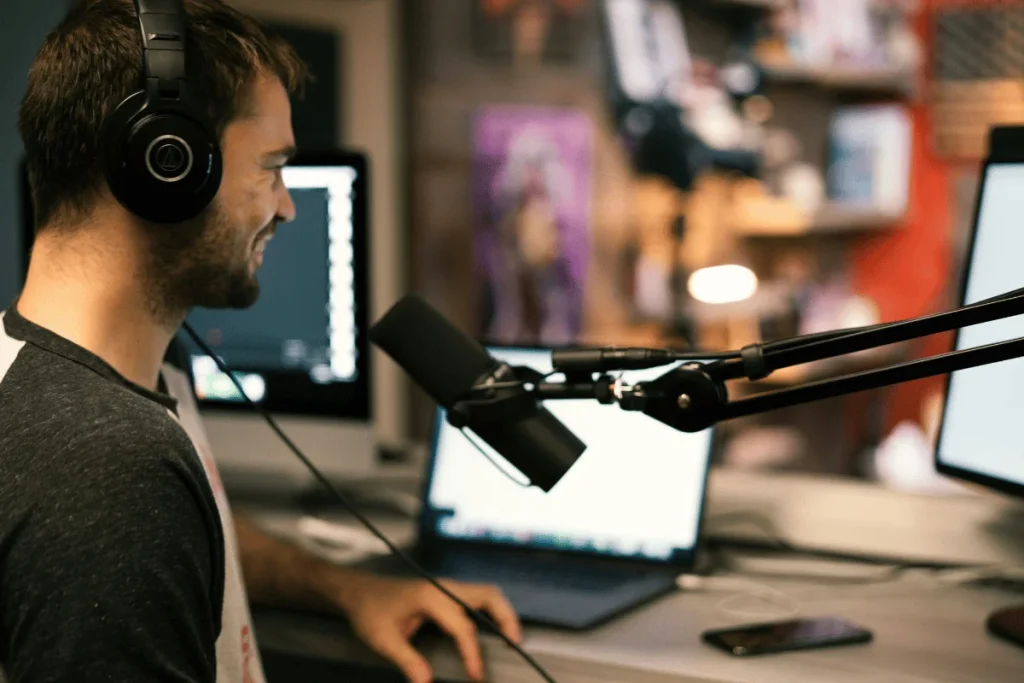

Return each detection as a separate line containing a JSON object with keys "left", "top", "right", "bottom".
{"left": 22, "top": 151, "right": 377, "bottom": 488}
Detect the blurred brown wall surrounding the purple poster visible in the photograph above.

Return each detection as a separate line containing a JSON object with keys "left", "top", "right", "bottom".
{"left": 408, "top": 0, "right": 630, "bottom": 439}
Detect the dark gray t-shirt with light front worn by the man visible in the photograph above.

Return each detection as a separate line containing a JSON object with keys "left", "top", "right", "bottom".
{"left": 0, "top": 308, "right": 263, "bottom": 683}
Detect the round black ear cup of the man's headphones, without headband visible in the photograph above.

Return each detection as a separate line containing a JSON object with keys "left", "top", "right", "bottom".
{"left": 104, "top": 92, "right": 223, "bottom": 223}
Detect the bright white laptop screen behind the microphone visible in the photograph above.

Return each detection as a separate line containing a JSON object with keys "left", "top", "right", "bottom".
{"left": 422, "top": 347, "right": 712, "bottom": 562}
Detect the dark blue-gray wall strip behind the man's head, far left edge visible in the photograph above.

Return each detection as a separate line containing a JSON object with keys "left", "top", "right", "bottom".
{"left": 0, "top": 1, "right": 70, "bottom": 309}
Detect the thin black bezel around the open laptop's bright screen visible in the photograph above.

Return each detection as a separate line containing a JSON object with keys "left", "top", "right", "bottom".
{"left": 417, "top": 342, "right": 718, "bottom": 570}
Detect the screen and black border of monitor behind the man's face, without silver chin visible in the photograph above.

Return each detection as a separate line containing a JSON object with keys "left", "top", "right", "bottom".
{"left": 187, "top": 155, "right": 370, "bottom": 418}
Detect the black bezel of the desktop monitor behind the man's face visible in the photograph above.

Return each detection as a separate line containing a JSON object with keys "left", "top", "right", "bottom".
{"left": 188, "top": 150, "right": 373, "bottom": 421}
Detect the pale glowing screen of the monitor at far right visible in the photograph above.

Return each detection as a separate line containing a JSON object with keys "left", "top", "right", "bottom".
{"left": 936, "top": 163, "right": 1024, "bottom": 493}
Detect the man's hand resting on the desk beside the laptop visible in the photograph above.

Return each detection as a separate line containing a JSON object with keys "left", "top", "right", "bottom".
{"left": 345, "top": 574, "right": 522, "bottom": 683}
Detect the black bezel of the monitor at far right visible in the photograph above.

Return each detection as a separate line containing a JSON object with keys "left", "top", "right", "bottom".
{"left": 933, "top": 152, "right": 1024, "bottom": 498}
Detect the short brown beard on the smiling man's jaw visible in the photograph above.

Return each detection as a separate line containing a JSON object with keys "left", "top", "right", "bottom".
{"left": 142, "top": 202, "right": 273, "bottom": 327}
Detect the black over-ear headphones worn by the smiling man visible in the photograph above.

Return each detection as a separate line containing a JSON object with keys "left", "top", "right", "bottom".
{"left": 103, "top": 0, "right": 223, "bottom": 223}
